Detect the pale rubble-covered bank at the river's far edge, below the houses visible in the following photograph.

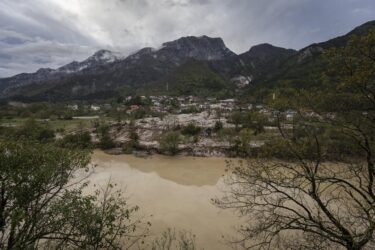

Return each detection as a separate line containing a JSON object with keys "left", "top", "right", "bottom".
{"left": 100, "top": 112, "right": 277, "bottom": 157}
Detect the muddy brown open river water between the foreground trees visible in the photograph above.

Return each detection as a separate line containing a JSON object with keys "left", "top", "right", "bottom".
{"left": 90, "top": 151, "right": 239, "bottom": 250}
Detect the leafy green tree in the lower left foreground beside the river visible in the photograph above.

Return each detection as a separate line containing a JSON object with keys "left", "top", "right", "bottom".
{"left": 0, "top": 142, "right": 147, "bottom": 249}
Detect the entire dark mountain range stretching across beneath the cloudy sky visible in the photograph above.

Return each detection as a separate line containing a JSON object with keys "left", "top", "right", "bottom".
{"left": 0, "top": 21, "right": 375, "bottom": 101}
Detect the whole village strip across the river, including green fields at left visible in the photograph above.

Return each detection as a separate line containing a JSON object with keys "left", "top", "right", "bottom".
{"left": 0, "top": 96, "right": 326, "bottom": 157}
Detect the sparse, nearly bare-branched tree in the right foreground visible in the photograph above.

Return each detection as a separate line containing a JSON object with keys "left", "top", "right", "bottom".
{"left": 215, "top": 31, "right": 375, "bottom": 249}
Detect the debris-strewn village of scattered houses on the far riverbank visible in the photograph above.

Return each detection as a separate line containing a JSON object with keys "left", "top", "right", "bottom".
{"left": 58, "top": 96, "right": 306, "bottom": 156}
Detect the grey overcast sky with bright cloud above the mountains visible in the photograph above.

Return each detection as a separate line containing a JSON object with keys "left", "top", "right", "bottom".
{"left": 0, "top": 0, "right": 375, "bottom": 77}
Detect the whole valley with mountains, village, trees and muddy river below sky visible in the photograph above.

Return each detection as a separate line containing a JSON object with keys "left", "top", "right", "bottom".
{"left": 0, "top": 12, "right": 375, "bottom": 250}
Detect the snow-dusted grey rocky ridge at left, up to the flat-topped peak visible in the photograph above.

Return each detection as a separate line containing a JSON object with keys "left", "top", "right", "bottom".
{"left": 0, "top": 36, "right": 241, "bottom": 100}
